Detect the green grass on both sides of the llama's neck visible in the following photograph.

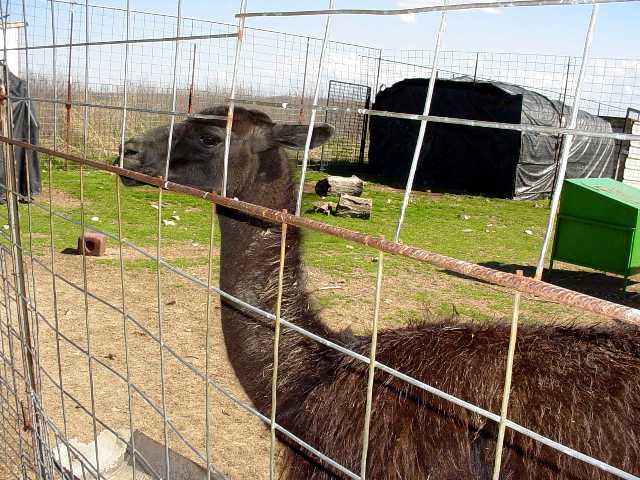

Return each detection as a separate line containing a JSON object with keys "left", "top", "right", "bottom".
{"left": 10, "top": 161, "right": 548, "bottom": 269}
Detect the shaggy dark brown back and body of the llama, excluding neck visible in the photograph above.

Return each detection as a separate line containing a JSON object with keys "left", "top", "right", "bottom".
{"left": 284, "top": 320, "right": 640, "bottom": 480}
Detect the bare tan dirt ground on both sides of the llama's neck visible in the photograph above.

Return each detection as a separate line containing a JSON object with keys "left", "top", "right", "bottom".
{"left": 0, "top": 236, "right": 632, "bottom": 480}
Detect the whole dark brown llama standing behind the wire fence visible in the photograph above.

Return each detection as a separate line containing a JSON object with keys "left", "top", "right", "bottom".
{"left": 122, "top": 106, "right": 640, "bottom": 480}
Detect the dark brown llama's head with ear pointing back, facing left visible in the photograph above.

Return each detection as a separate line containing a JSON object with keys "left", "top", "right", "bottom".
{"left": 114, "top": 106, "right": 334, "bottom": 195}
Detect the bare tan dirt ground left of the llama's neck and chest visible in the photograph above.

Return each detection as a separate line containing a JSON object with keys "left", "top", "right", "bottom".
{"left": 9, "top": 251, "right": 269, "bottom": 479}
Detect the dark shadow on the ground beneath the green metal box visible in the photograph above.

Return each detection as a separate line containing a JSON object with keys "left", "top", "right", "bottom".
{"left": 443, "top": 261, "right": 640, "bottom": 308}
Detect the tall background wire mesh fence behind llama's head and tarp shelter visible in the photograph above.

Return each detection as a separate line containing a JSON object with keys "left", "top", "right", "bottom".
{"left": 2, "top": 0, "right": 640, "bottom": 167}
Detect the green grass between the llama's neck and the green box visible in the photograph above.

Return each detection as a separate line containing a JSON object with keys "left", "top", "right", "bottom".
{"left": 304, "top": 172, "right": 548, "bottom": 274}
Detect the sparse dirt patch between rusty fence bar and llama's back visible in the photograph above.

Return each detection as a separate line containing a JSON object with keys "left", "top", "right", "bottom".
{"left": 307, "top": 258, "right": 616, "bottom": 334}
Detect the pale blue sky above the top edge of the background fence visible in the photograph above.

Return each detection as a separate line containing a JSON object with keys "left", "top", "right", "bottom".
{"left": 92, "top": 0, "right": 640, "bottom": 58}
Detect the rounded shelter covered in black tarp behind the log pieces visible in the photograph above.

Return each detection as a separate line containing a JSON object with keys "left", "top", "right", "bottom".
{"left": 369, "top": 77, "right": 617, "bottom": 199}
